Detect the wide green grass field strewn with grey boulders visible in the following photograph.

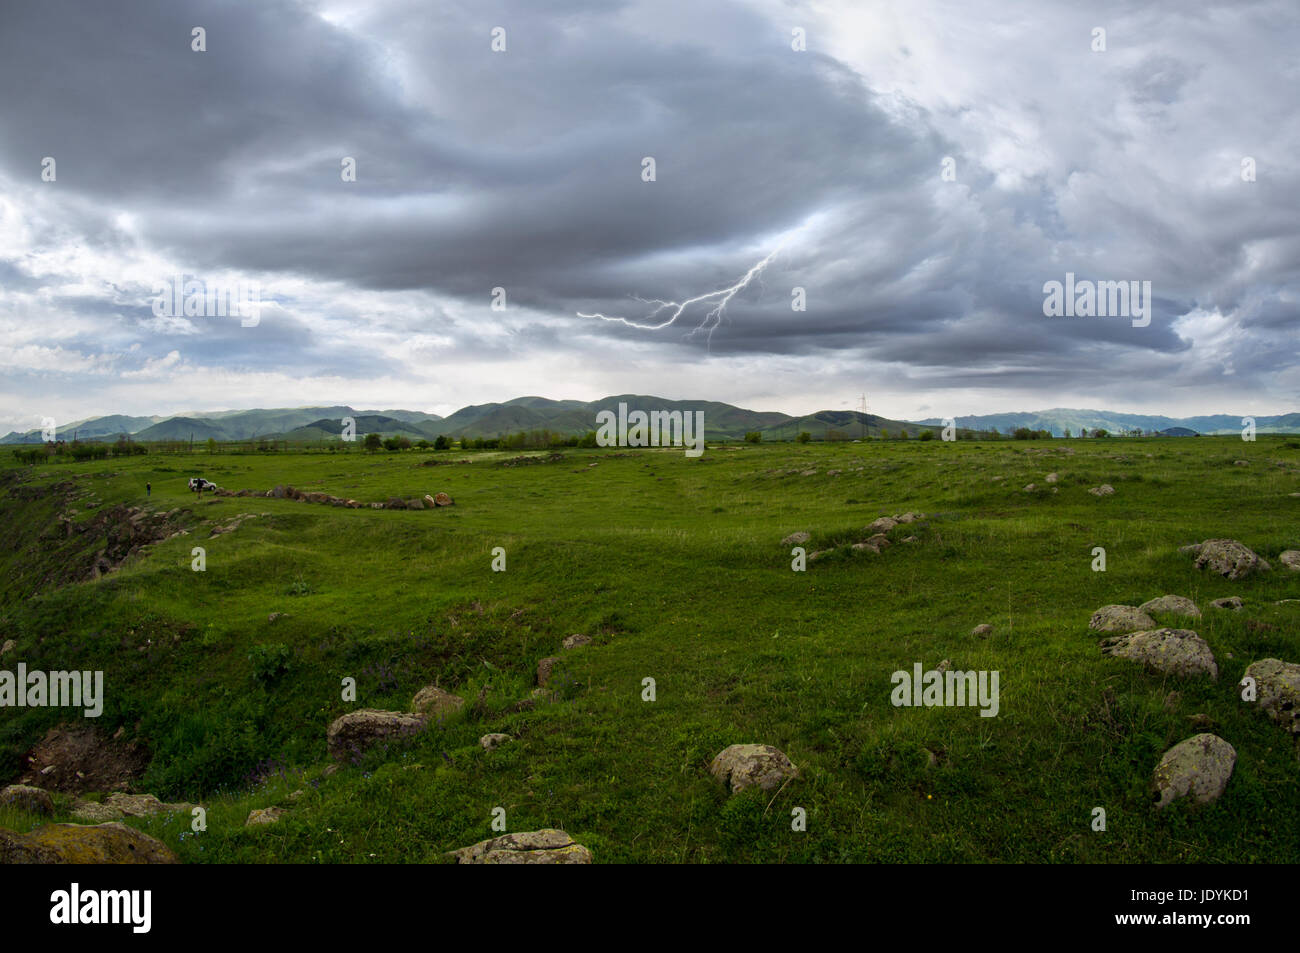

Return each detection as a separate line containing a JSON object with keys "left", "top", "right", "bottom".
{"left": 0, "top": 437, "right": 1300, "bottom": 863}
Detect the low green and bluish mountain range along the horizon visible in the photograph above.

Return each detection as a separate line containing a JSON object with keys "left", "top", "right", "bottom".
{"left": 0, "top": 394, "right": 1300, "bottom": 443}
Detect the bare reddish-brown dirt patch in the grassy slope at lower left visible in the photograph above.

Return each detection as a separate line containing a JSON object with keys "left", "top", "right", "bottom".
{"left": 18, "top": 724, "right": 152, "bottom": 794}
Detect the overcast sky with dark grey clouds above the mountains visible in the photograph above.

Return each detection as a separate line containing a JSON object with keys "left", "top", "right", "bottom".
{"left": 0, "top": 0, "right": 1300, "bottom": 432}
